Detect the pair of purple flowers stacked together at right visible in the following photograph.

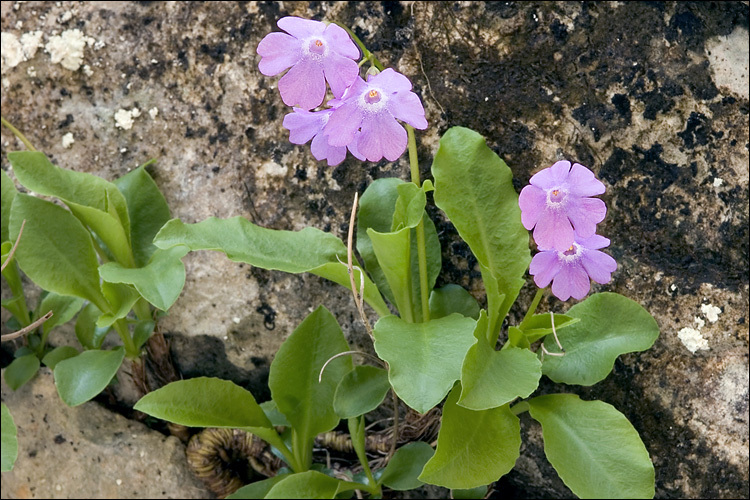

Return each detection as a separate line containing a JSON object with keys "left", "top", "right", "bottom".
{"left": 518, "top": 161, "right": 617, "bottom": 300}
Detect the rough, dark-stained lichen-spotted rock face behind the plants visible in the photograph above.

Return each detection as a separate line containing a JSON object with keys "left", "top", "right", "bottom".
{"left": 2, "top": 2, "right": 750, "bottom": 498}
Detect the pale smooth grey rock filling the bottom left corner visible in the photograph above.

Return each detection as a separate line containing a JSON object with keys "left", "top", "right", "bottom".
{"left": 0, "top": 368, "right": 210, "bottom": 498}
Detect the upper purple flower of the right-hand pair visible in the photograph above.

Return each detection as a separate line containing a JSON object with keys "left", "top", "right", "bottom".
{"left": 518, "top": 161, "right": 607, "bottom": 252}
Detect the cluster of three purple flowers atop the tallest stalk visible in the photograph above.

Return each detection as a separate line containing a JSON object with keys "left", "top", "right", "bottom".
{"left": 258, "top": 17, "right": 427, "bottom": 166}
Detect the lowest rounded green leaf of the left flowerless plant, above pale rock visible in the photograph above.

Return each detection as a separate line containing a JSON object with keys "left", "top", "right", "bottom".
{"left": 54, "top": 347, "right": 125, "bottom": 406}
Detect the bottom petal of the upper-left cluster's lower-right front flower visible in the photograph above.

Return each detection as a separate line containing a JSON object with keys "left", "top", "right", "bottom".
{"left": 357, "top": 110, "right": 408, "bottom": 161}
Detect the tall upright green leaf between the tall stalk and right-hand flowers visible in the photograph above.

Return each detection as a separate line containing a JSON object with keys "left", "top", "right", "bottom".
{"left": 432, "top": 127, "right": 531, "bottom": 339}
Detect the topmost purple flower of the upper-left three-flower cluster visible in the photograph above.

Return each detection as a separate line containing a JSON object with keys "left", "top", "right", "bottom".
{"left": 258, "top": 17, "right": 359, "bottom": 110}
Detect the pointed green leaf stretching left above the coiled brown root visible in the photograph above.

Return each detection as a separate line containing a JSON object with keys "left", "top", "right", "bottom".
{"left": 133, "top": 377, "right": 271, "bottom": 432}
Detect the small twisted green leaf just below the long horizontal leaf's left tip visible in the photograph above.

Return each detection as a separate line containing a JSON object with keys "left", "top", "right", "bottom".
{"left": 99, "top": 245, "right": 189, "bottom": 311}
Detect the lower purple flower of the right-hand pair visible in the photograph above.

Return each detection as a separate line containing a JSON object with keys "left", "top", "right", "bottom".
{"left": 529, "top": 234, "right": 617, "bottom": 300}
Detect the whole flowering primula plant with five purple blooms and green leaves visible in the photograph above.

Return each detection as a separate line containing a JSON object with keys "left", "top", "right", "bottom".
{"left": 136, "top": 17, "right": 659, "bottom": 498}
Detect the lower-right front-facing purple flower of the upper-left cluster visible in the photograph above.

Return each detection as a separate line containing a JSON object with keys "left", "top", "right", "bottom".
{"left": 323, "top": 68, "right": 427, "bottom": 161}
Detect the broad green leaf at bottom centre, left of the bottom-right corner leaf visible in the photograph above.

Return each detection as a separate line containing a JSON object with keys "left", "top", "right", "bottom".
{"left": 419, "top": 385, "right": 521, "bottom": 489}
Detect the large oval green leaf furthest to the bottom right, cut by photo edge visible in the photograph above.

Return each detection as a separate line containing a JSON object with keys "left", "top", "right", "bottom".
{"left": 529, "top": 394, "right": 654, "bottom": 498}
